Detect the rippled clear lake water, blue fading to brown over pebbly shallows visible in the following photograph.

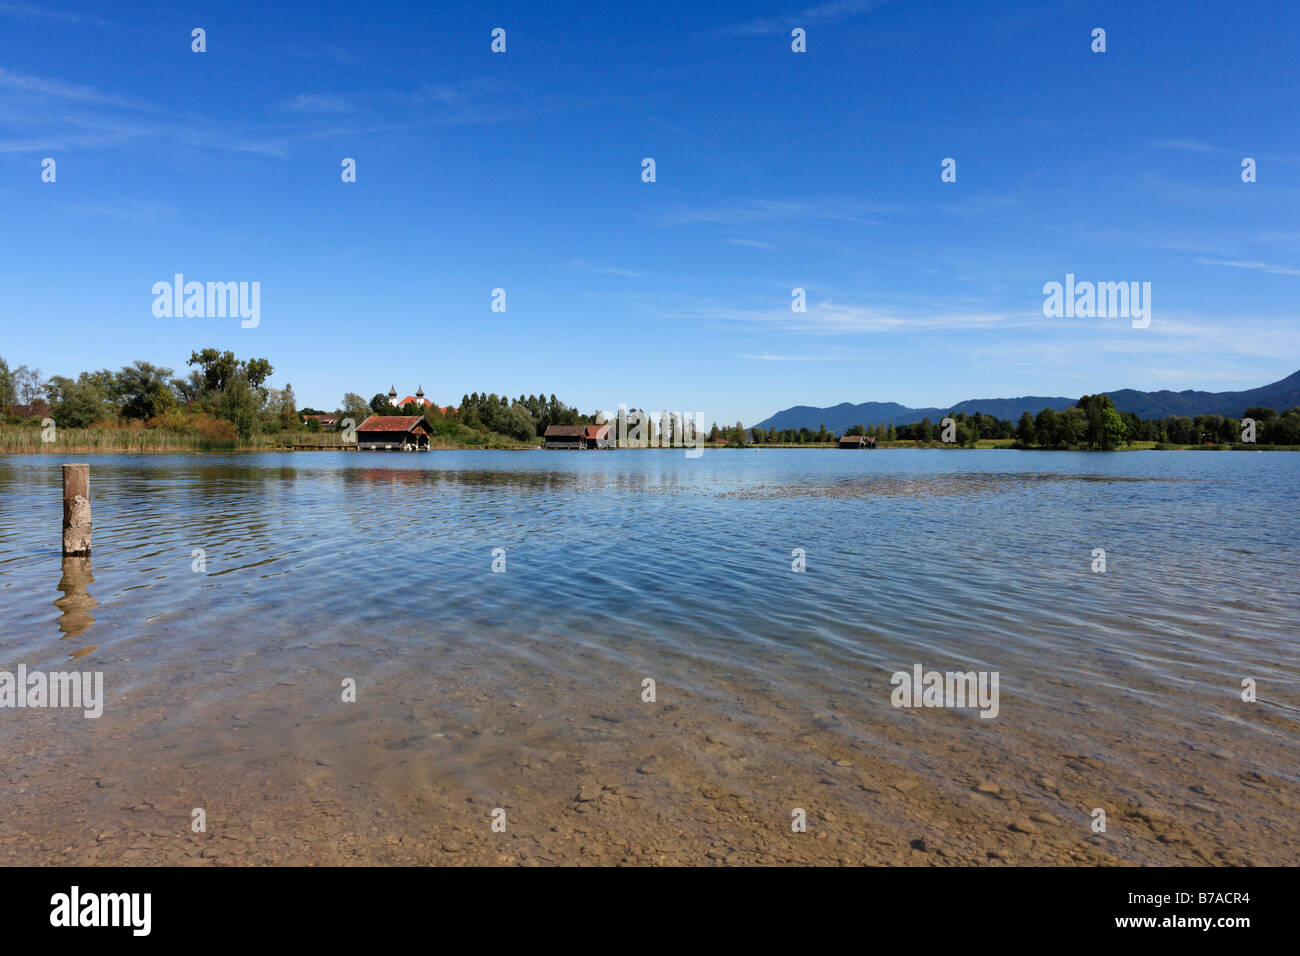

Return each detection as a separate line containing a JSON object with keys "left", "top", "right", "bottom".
{"left": 0, "top": 449, "right": 1300, "bottom": 865}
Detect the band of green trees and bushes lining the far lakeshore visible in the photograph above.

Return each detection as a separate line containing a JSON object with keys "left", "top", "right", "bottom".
{"left": 10, "top": 349, "right": 1300, "bottom": 450}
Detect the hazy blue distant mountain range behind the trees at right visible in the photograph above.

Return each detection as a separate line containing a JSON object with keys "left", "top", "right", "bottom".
{"left": 754, "top": 372, "right": 1300, "bottom": 434}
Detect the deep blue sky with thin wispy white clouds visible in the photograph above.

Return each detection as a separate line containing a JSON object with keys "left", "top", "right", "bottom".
{"left": 0, "top": 0, "right": 1300, "bottom": 424}
